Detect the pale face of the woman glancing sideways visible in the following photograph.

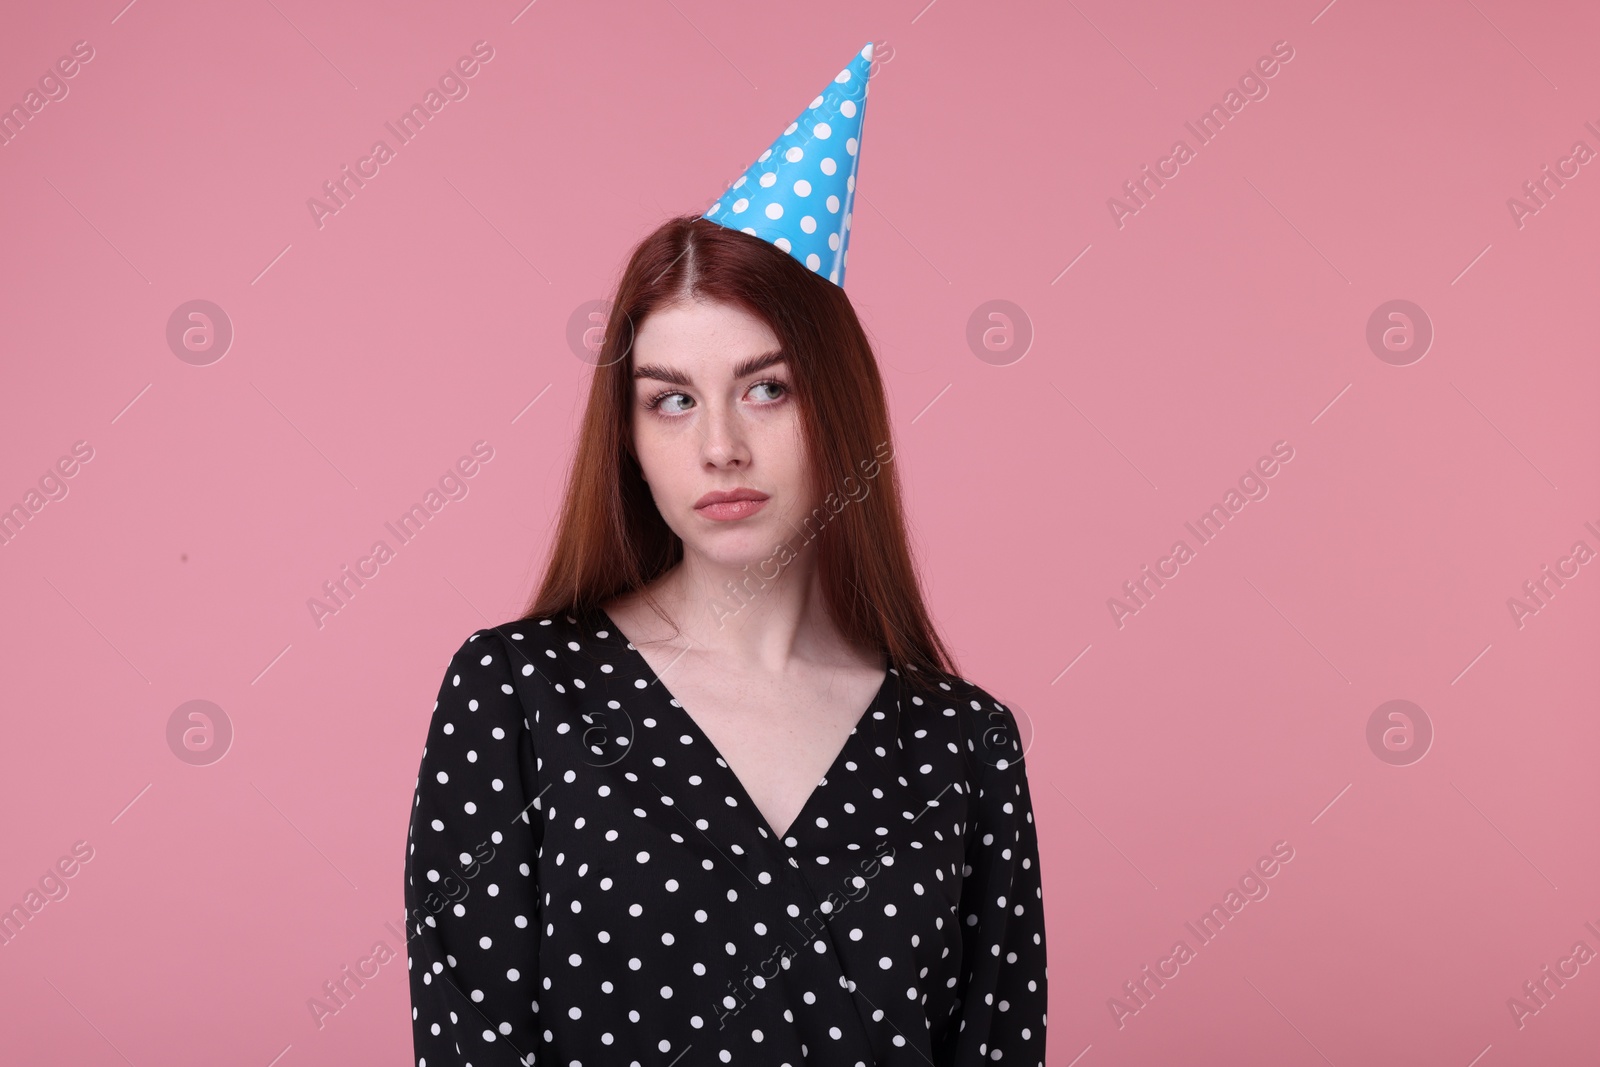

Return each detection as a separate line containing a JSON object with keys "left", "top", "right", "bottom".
{"left": 632, "top": 299, "right": 813, "bottom": 568}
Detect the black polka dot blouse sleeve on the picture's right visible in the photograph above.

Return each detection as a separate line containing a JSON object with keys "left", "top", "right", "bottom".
{"left": 954, "top": 689, "right": 1048, "bottom": 1067}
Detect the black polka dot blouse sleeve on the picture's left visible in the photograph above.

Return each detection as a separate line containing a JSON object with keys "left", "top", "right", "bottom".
{"left": 405, "top": 630, "right": 544, "bottom": 1067}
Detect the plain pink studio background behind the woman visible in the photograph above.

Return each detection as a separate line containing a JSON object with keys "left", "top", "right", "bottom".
{"left": 0, "top": 0, "right": 1600, "bottom": 1067}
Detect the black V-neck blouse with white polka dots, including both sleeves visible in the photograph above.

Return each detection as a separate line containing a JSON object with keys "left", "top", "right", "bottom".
{"left": 405, "top": 609, "right": 1046, "bottom": 1067}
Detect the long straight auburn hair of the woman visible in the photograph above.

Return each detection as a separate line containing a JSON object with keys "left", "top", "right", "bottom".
{"left": 522, "top": 216, "right": 955, "bottom": 685}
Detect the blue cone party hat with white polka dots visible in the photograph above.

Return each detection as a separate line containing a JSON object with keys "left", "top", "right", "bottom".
{"left": 702, "top": 43, "right": 872, "bottom": 288}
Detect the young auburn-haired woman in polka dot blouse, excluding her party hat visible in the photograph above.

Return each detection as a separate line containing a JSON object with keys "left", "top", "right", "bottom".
{"left": 405, "top": 218, "right": 1046, "bottom": 1067}
